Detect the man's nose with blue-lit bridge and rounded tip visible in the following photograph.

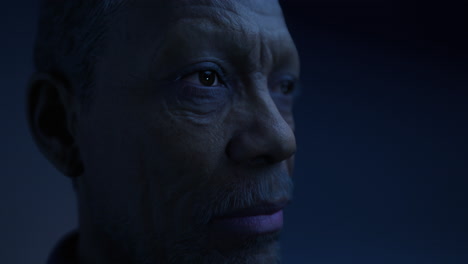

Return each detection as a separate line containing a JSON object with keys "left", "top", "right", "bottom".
{"left": 226, "top": 93, "right": 296, "bottom": 165}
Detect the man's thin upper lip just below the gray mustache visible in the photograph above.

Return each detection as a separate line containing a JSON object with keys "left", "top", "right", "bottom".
{"left": 216, "top": 199, "right": 289, "bottom": 219}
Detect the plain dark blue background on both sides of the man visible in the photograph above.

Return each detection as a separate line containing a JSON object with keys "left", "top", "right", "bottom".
{"left": 0, "top": 0, "right": 468, "bottom": 264}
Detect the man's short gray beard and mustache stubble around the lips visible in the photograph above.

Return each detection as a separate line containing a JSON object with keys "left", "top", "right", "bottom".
{"left": 102, "top": 167, "right": 293, "bottom": 264}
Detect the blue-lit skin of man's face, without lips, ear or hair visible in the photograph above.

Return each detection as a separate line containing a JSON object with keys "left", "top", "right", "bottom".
{"left": 31, "top": 0, "right": 299, "bottom": 264}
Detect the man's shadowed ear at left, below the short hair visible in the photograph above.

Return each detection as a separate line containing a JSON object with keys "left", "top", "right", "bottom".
{"left": 26, "top": 73, "right": 83, "bottom": 177}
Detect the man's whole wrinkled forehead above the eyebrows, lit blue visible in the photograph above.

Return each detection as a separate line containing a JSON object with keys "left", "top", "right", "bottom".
{"left": 100, "top": 0, "right": 299, "bottom": 84}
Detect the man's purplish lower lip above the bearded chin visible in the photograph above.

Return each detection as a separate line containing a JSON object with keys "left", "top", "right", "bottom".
{"left": 213, "top": 210, "right": 283, "bottom": 235}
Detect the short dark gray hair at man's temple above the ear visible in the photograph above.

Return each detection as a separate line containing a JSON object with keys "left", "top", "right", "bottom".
{"left": 34, "top": 0, "right": 126, "bottom": 110}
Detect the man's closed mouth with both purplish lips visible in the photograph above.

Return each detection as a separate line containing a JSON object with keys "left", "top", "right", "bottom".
{"left": 212, "top": 199, "right": 289, "bottom": 238}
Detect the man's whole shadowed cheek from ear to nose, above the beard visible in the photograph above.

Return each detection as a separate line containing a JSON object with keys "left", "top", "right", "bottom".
{"left": 80, "top": 90, "right": 226, "bottom": 232}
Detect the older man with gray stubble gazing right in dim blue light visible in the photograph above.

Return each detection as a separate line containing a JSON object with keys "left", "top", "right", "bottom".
{"left": 28, "top": 0, "right": 299, "bottom": 264}
